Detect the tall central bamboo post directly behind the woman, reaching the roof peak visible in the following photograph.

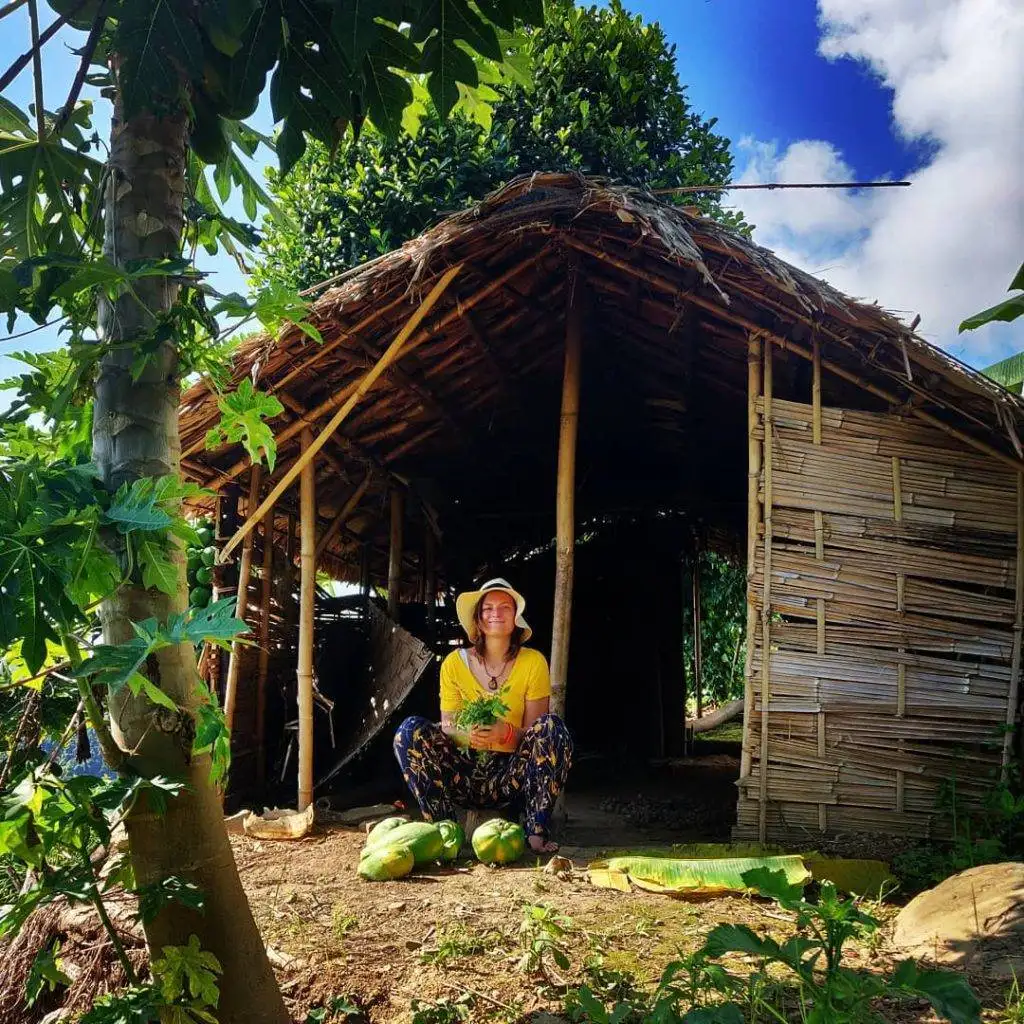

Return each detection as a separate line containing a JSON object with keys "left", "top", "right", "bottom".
{"left": 551, "top": 257, "right": 583, "bottom": 716}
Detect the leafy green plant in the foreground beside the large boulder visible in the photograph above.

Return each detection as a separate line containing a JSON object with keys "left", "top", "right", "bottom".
{"left": 699, "top": 868, "right": 981, "bottom": 1024}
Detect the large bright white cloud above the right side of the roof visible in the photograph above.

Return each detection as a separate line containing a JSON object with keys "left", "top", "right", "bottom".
{"left": 739, "top": 0, "right": 1024, "bottom": 365}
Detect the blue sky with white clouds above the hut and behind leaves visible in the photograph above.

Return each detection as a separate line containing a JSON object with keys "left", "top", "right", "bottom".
{"left": 0, "top": 0, "right": 1024, "bottom": 385}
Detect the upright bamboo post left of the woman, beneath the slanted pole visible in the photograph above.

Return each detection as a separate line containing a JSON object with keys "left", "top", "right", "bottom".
{"left": 297, "top": 427, "right": 316, "bottom": 811}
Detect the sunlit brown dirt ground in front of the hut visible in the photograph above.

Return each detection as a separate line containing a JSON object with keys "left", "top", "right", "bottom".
{"left": 232, "top": 828, "right": 1011, "bottom": 1024}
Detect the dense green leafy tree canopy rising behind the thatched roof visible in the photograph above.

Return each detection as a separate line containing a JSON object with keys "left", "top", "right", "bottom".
{"left": 255, "top": 0, "right": 742, "bottom": 288}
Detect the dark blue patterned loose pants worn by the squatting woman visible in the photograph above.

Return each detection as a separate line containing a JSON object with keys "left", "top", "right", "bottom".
{"left": 394, "top": 715, "right": 572, "bottom": 836}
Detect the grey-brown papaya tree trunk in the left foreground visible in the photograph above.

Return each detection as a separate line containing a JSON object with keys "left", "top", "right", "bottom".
{"left": 92, "top": 99, "right": 289, "bottom": 1024}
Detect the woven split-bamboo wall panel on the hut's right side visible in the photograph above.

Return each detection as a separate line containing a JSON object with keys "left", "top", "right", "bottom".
{"left": 735, "top": 341, "right": 1022, "bottom": 842}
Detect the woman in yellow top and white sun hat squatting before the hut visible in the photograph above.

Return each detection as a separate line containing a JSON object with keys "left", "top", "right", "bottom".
{"left": 394, "top": 579, "right": 572, "bottom": 853}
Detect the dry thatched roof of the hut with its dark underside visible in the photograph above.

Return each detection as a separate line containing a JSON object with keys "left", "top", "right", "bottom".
{"left": 180, "top": 174, "right": 1024, "bottom": 578}
